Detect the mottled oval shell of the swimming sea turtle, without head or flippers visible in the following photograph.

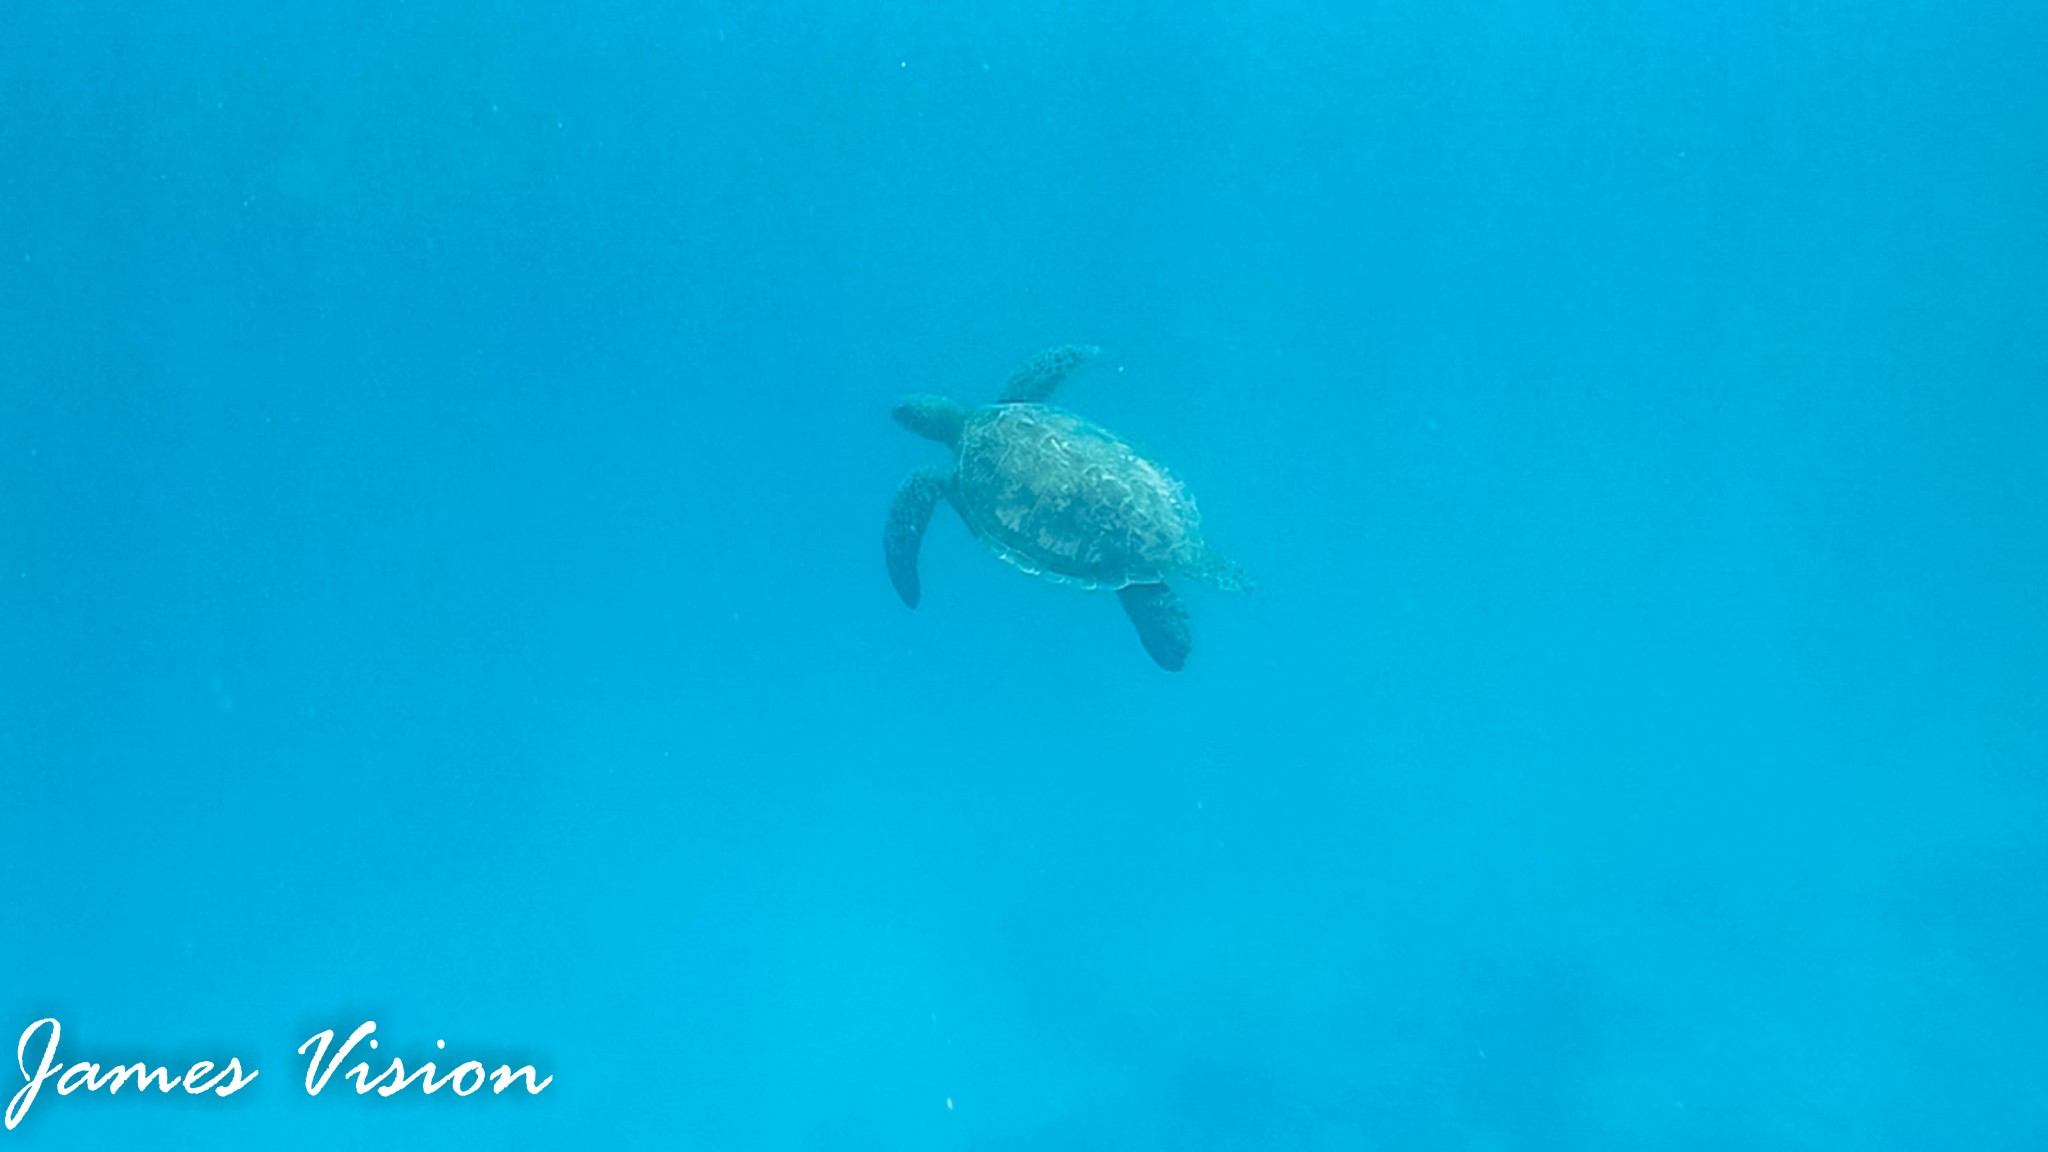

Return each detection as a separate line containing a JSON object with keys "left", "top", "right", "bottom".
{"left": 952, "top": 404, "right": 1206, "bottom": 588}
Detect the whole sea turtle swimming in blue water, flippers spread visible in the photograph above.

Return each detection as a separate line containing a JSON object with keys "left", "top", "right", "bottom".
{"left": 883, "top": 344, "right": 1249, "bottom": 670}
